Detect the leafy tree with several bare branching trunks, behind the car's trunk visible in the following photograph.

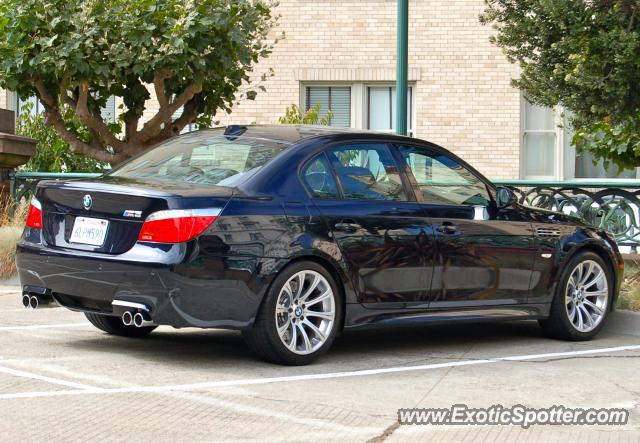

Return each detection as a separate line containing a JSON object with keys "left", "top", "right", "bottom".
{"left": 0, "top": 0, "right": 276, "bottom": 165}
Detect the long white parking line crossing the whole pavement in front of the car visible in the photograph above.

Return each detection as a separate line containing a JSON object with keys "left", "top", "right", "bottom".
{"left": 0, "top": 345, "right": 640, "bottom": 400}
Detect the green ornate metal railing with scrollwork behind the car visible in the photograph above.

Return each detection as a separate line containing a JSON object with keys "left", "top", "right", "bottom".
{"left": 10, "top": 172, "right": 640, "bottom": 252}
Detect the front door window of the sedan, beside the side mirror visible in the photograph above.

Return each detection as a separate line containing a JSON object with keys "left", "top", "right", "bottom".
{"left": 399, "top": 146, "right": 491, "bottom": 206}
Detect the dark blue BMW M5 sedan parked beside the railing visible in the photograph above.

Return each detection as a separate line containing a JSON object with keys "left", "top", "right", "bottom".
{"left": 17, "top": 126, "right": 624, "bottom": 365}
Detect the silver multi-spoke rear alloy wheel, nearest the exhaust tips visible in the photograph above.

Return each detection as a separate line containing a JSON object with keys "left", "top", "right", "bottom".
{"left": 275, "top": 270, "right": 336, "bottom": 355}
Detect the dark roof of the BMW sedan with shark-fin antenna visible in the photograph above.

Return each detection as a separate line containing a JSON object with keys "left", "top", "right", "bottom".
{"left": 188, "top": 125, "right": 415, "bottom": 145}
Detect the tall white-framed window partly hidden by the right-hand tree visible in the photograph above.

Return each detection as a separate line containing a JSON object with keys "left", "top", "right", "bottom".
{"left": 521, "top": 97, "right": 639, "bottom": 180}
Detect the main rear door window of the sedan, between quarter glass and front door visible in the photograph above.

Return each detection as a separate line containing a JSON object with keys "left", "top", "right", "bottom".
{"left": 327, "top": 144, "right": 407, "bottom": 200}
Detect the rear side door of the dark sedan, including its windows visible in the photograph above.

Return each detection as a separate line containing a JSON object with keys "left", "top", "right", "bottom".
{"left": 302, "top": 143, "right": 435, "bottom": 308}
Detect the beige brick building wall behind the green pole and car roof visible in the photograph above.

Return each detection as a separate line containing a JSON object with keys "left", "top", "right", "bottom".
{"left": 212, "top": 0, "right": 520, "bottom": 178}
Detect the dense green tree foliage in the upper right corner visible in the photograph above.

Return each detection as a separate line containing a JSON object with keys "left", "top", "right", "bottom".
{"left": 480, "top": 0, "right": 640, "bottom": 167}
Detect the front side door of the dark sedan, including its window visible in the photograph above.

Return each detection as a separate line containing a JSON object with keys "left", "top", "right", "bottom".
{"left": 398, "top": 146, "right": 537, "bottom": 308}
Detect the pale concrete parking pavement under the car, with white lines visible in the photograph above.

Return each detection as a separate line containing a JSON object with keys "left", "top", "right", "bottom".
{"left": 0, "top": 286, "right": 640, "bottom": 442}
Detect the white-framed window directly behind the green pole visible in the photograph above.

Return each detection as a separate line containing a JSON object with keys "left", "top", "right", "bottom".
{"left": 367, "top": 86, "right": 413, "bottom": 135}
